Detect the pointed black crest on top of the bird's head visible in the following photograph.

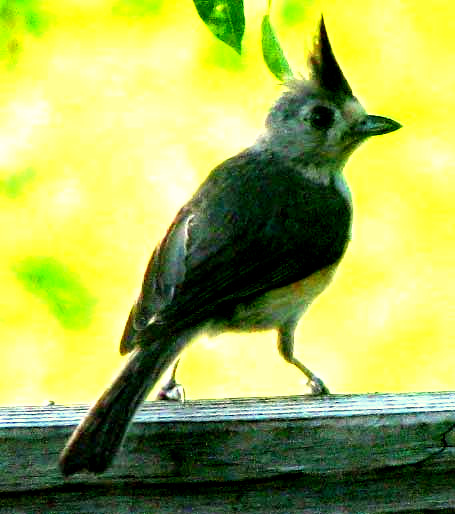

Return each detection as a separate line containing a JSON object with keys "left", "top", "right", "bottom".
{"left": 309, "top": 16, "right": 353, "bottom": 98}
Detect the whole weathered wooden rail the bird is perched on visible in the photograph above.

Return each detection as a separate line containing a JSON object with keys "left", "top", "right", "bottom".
{"left": 0, "top": 392, "right": 455, "bottom": 512}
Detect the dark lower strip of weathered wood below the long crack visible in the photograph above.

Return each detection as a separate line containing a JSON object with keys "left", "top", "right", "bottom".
{"left": 0, "top": 467, "right": 455, "bottom": 514}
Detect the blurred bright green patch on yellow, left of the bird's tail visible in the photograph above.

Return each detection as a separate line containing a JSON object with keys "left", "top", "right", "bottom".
{"left": 13, "top": 257, "right": 95, "bottom": 330}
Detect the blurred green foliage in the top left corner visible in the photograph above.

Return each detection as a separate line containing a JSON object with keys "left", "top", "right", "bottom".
{"left": 0, "top": 0, "right": 50, "bottom": 68}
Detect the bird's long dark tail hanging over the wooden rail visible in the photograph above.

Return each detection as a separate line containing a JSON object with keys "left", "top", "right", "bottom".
{"left": 59, "top": 336, "right": 188, "bottom": 475}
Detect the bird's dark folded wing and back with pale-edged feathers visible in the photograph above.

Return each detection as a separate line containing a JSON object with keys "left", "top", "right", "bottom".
{"left": 121, "top": 153, "right": 351, "bottom": 351}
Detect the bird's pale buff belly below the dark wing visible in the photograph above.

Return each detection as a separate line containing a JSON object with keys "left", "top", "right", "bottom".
{"left": 223, "top": 263, "right": 337, "bottom": 331}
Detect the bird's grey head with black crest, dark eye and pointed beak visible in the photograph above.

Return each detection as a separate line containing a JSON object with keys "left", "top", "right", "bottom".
{"left": 259, "top": 17, "right": 401, "bottom": 169}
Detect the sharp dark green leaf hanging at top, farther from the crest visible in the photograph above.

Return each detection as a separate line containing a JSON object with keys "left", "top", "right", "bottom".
{"left": 193, "top": 0, "right": 245, "bottom": 54}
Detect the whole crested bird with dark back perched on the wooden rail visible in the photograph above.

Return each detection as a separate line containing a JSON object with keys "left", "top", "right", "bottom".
{"left": 59, "top": 16, "right": 401, "bottom": 476}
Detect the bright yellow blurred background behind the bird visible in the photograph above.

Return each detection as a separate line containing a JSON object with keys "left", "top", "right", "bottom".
{"left": 0, "top": 0, "right": 455, "bottom": 404}
